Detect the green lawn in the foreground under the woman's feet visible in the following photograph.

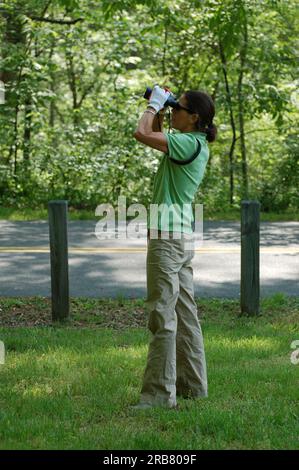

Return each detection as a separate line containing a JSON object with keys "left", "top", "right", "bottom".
{"left": 0, "top": 293, "right": 299, "bottom": 450}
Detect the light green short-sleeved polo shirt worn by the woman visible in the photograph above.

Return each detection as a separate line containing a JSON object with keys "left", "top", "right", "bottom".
{"left": 147, "top": 132, "right": 209, "bottom": 233}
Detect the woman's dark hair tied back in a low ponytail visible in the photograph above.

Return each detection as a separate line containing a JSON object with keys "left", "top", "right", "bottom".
{"left": 184, "top": 90, "right": 217, "bottom": 142}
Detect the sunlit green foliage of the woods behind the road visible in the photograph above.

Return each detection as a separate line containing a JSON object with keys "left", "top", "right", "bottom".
{"left": 0, "top": 0, "right": 299, "bottom": 213}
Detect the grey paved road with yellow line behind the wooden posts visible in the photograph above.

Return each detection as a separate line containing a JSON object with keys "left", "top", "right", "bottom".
{"left": 0, "top": 220, "right": 299, "bottom": 298}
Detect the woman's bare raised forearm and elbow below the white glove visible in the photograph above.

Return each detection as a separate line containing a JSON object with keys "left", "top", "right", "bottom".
{"left": 133, "top": 108, "right": 168, "bottom": 153}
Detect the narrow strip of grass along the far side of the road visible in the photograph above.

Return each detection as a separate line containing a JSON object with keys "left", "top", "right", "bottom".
{"left": 0, "top": 206, "right": 299, "bottom": 222}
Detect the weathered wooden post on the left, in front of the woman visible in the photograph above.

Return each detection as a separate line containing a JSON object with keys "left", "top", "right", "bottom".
{"left": 48, "top": 201, "right": 69, "bottom": 321}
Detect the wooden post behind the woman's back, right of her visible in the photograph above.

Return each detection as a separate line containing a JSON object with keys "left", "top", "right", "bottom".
{"left": 241, "top": 201, "right": 260, "bottom": 315}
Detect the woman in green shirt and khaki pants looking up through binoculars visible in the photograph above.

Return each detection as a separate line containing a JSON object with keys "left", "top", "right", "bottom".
{"left": 133, "top": 86, "right": 217, "bottom": 409}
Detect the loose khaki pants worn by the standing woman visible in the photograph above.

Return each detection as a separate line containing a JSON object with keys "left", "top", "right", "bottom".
{"left": 140, "top": 231, "right": 207, "bottom": 408}
